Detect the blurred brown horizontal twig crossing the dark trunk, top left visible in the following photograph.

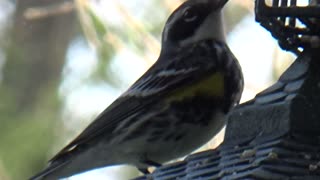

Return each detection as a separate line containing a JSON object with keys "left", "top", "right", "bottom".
{"left": 23, "top": 1, "right": 75, "bottom": 20}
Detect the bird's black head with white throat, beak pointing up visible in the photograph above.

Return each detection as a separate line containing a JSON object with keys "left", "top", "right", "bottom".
{"left": 162, "top": 0, "right": 228, "bottom": 51}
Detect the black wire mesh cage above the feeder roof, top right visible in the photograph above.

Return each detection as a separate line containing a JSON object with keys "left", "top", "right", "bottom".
{"left": 255, "top": 0, "right": 320, "bottom": 54}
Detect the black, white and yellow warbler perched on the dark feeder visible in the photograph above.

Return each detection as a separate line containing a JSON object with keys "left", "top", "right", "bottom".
{"left": 32, "top": 0, "right": 243, "bottom": 179}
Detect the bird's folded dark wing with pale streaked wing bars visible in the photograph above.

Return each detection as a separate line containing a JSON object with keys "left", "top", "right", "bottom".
{"left": 50, "top": 57, "right": 218, "bottom": 162}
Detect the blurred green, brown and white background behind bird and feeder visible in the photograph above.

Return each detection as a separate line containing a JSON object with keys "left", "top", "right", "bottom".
{"left": 0, "top": 0, "right": 303, "bottom": 180}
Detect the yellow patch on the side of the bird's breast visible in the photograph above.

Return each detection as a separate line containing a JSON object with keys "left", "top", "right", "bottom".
{"left": 168, "top": 72, "right": 224, "bottom": 101}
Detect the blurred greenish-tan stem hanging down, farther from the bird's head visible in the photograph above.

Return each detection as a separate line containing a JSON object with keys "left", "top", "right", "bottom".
{"left": 75, "top": 0, "right": 122, "bottom": 87}
